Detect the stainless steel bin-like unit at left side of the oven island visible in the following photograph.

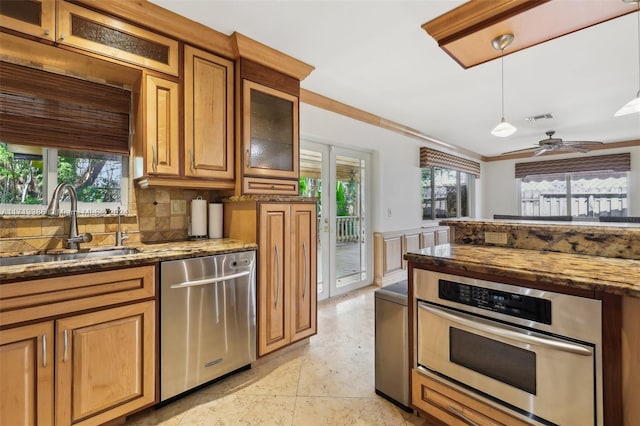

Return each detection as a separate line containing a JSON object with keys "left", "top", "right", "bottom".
{"left": 374, "top": 281, "right": 413, "bottom": 411}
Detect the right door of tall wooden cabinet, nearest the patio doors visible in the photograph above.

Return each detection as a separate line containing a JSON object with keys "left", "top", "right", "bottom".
{"left": 290, "top": 204, "right": 318, "bottom": 341}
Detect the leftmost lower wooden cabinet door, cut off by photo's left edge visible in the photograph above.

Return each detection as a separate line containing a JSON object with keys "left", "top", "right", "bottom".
{"left": 0, "top": 321, "right": 54, "bottom": 426}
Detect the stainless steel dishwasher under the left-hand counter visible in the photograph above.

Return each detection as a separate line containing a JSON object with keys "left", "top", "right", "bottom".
{"left": 160, "top": 251, "right": 256, "bottom": 401}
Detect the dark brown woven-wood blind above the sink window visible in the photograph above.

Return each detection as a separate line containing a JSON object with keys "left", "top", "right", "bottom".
{"left": 0, "top": 62, "right": 131, "bottom": 155}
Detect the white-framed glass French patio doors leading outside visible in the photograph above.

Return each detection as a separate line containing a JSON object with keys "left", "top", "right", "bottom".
{"left": 300, "top": 141, "right": 373, "bottom": 299}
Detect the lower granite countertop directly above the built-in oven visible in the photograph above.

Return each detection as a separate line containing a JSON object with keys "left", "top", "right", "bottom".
{"left": 405, "top": 244, "right": 640, "bottom": 297}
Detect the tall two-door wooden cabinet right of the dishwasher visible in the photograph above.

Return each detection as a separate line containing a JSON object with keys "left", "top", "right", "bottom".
{"left": 223, "top": 201, "right": 317, "bottom": 356}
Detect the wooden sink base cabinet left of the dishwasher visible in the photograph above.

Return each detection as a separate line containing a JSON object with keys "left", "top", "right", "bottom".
{"left": 0, "top": 265, "right": 156, "bottom": 426}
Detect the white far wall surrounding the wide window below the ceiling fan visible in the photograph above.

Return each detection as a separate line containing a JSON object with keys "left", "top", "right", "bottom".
{"left": 477, "top": 147, "right": 640, "bottom": 219}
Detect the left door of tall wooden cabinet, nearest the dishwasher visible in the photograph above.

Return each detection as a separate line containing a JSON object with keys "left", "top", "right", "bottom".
{"left": 258, "top": 204, "right": 291, "bottom": 355}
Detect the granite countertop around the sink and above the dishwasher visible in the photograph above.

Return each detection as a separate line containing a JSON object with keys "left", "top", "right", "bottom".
{"left": 0, "top": 238, "right": 258, "bottom": 284}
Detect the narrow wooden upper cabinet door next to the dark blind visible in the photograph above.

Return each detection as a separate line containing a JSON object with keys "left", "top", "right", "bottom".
{"left": 144, "top": 75, "right": 180, "bottom": 176}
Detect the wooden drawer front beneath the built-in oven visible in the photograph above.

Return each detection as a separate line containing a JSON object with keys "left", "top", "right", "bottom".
{"left": 411, "top": 369, "right": 531, "bottom": 426}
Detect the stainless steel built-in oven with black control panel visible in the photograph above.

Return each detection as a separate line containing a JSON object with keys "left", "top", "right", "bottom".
{"left": 414, "top": 269, "right": 603, "bottom": 426}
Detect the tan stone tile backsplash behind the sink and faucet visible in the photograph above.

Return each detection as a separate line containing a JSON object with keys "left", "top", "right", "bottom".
{"left": 0, "top": 188, "right": 217, "bottom": 253}
